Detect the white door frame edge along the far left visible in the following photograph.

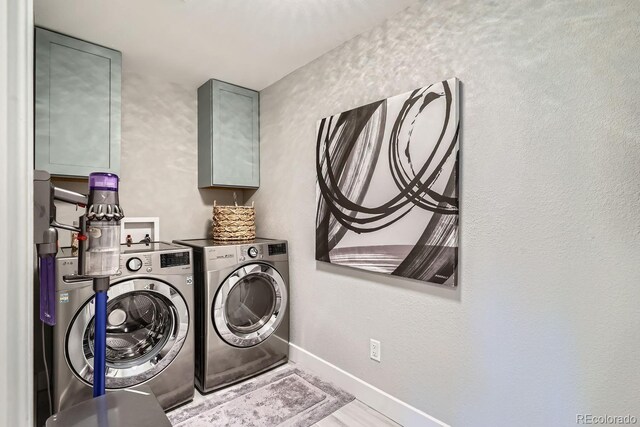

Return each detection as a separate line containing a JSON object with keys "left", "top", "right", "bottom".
{"left": 0, "top": 0, "right": 35, "bottom": 426}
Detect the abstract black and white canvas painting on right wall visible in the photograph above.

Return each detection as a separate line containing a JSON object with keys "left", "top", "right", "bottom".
{"left": 316, "top": 78, "right": 459, "bottom": 286}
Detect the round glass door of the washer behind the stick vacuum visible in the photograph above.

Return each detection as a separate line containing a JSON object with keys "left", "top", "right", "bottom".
{"left": 65, "top": 279, "right": 189, "bottom": 388}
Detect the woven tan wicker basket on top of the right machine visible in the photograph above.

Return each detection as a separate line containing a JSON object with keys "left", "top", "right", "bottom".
{"left": 211, "top": 201, "right": 256, "bottom": 242}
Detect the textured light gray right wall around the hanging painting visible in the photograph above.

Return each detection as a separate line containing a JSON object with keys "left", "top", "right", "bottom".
{"left": 250, "top": 0, "right": 640, "bottom": 426}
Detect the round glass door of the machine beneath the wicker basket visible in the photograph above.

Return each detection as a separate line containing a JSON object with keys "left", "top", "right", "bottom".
{"left": 212, "top": 263, "right": 287, "bottom": 347}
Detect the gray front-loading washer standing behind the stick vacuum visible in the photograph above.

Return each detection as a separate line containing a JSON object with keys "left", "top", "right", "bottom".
{"left": 52, "top": 242, "right": 194, "bottom": 412}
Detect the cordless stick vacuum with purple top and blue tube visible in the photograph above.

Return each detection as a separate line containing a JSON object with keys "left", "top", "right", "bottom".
{"left": 34, "top": 171, "right": 124, "bottom": 397}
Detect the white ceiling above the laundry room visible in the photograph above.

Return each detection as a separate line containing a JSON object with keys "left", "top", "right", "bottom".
{"left": 34, "top": 0, "right": 417, "bottom": 90}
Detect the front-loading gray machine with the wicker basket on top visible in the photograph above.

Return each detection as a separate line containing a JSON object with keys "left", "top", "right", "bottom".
{"left": 175, "top": 239, "right": 289, "bottom": 393}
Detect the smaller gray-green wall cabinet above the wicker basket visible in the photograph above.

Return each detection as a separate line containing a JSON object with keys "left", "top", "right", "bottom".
{"left": 198, "top": 80, "right": 260, "bottom": 188}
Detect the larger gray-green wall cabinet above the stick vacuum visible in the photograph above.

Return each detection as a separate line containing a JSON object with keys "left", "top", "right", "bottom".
{"left": 35, "top": 28, "right": 122, "bottom": 177}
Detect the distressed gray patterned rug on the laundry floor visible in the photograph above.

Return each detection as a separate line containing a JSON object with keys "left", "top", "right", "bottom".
{"left": 167, "top": 364, "right": 355, "bottom": 427}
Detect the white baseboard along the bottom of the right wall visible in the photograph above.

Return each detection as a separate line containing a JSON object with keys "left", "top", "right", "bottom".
{"left": 289, "top": 343, "right": 449, "bottom": 427}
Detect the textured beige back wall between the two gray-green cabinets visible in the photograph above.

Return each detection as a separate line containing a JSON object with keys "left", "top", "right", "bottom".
{"left": 56, "top": 72, "right": 243, "bottom": 245}
